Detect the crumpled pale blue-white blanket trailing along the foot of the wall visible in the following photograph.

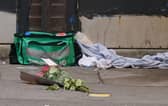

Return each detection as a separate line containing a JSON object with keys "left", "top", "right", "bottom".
{"left": 78, "top": 41, "right": 168, "bottom": 69}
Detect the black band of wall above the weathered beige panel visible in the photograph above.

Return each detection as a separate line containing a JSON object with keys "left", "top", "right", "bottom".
{"left": 79, "top": 0, "right": 168, "bottom": 16}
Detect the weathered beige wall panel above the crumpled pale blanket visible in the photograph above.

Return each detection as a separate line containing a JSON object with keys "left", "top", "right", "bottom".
{"left": 80, "top": 15, "right": 168, "bottom": 48}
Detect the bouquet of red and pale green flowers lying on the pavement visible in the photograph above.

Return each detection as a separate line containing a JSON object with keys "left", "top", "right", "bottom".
{"left": 37, "top": 66, "right": 89, "bottom": 93}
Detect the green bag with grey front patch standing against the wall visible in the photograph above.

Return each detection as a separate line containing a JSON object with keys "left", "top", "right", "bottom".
{"left": 14, "top": 32, "right": 75, "bottom": 66}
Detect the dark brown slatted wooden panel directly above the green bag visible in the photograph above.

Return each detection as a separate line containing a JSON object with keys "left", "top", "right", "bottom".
{"left": 26, "top": 0, "right": 76, "bottom": 32}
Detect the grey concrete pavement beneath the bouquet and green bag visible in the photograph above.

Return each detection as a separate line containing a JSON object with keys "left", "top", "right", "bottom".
{"left": 0, "top": 64, "right": 168, "bottom": 106}
